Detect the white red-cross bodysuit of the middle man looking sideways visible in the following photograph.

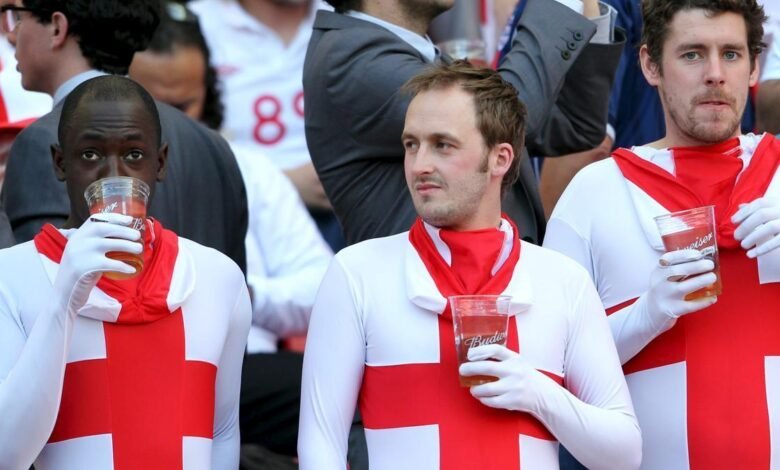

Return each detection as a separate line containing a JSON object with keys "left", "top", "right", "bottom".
{"left": 298, "top": 221, "right": 637, "bottom": 470}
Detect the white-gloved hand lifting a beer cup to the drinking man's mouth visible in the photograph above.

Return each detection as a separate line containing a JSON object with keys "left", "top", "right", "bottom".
{"left": 54, "top": 213, "right": 143, "bottom": 315}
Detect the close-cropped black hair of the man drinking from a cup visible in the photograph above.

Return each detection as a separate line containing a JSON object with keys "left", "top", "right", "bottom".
{"left": 57, "top": 75, "right": 162, "bottom": 147}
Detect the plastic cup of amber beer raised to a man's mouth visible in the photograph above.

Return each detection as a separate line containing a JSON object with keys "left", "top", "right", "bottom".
{"left": 84, "top": 176, "right": 149, "bottom": 280}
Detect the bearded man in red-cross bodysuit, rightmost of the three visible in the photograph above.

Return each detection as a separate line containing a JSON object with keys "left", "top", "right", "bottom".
{"left": 544, "top": 0, "right": 780, "bottom": 470}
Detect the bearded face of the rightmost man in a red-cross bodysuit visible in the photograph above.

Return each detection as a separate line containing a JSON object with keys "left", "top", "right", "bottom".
{"left": 640, "top": 9, "right": 758, "bottom": 146}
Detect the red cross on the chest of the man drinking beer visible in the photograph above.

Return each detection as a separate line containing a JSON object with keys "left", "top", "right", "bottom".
{"left": 49, "top": 309, "right": 217, "bottom": 470}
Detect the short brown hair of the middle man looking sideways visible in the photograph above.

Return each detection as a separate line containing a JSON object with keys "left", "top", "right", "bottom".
{"left": 402, "top": 60, "right": 526, "bottom": 196}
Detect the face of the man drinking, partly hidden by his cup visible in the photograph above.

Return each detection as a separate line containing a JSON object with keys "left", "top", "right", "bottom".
{"left": 52, "top": 98, "right": 168, "bottom": 227}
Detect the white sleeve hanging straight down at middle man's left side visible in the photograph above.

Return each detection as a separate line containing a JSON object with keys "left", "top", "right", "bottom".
{"left": 298, "top": 258, "right": 366, "bottom": 470}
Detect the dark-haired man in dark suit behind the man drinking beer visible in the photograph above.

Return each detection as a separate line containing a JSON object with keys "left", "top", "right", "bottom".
{"left": 2, "top": 0, "right": 247, "bottom": 270}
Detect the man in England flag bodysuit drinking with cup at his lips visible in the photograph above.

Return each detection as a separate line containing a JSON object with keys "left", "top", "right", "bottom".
{"left": 0, "top": 76, "right": 251, "bottom": 470}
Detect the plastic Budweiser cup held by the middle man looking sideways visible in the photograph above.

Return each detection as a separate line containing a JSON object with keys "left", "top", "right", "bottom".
{"left": 449, "top": 295, "right": 512, "bottom": 387}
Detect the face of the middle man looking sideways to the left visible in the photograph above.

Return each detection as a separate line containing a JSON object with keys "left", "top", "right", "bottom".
{"left": 402, "top": 87, "right": 511, "bottom": 230}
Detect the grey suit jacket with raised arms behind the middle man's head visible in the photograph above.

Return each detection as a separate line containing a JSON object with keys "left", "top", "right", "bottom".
{"left": 303, "top": 0, "right": 622, "bottom": 243}
